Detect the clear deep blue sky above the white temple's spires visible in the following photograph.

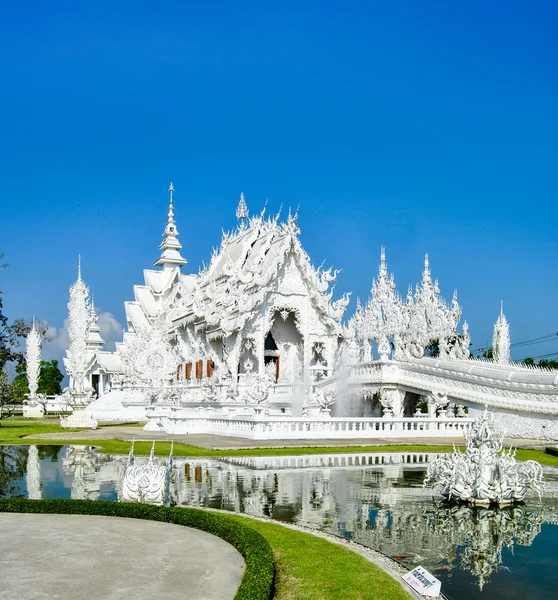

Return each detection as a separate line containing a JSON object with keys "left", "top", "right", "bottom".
{"left": 0, "top": 1, "right": 558, "bottom": 358}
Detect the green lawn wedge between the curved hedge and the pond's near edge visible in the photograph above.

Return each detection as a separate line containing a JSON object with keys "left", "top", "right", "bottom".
{"left": 223, "top": 515, "right": 410, "bottom": 600}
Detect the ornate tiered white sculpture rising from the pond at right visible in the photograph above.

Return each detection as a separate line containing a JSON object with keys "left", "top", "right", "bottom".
{"left": 424, "top": 410, "right": 544, "bottom": 504}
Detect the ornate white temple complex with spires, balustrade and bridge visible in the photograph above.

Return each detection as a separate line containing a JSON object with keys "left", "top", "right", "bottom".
{"left": 52, "top": 184, "right": 558, "bottom": 439}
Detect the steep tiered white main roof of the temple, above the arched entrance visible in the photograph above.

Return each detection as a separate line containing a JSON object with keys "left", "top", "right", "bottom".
{"left": 168, "top": 207, "right": 348, "bottom": 335}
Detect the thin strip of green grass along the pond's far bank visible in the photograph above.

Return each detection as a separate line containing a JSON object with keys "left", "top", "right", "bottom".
{"left": 0, "top": 419, "right": 558, "bottom": 466}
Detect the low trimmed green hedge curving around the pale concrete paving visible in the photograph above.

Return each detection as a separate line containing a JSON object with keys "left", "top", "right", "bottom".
{"left": 0, "top": 498, "right": 275, "bottom": 600}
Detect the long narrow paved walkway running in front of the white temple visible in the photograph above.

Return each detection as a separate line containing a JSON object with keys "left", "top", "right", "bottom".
{"left": 27, "top": 425, "right": 551, "bottom": 450}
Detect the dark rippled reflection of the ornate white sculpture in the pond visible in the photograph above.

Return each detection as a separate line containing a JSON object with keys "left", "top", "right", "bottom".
{"left": 428, "top": 505, "right": 544, "bottom": 590}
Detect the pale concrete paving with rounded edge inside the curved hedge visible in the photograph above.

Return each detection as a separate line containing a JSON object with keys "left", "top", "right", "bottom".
{"left": 0, "top": 513, "right": 245, "bottom": 600}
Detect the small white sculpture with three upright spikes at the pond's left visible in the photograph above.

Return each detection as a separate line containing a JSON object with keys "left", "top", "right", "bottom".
{"left": 120, "top": 442, "right": 172, "bottom": 504}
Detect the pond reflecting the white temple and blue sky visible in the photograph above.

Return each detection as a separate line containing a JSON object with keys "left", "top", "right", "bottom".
{"left": 0, "top": 445, "right": 558, "bottom": 600}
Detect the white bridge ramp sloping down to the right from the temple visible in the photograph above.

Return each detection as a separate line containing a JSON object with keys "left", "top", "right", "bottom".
{"left": 342, "top": 358, "right": 558, "bottom": 440}
